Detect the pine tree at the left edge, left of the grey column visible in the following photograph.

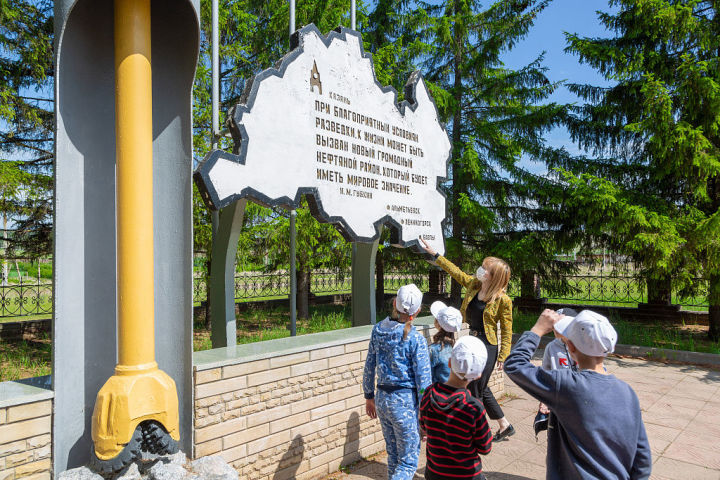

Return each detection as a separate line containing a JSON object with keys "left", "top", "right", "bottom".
{"left": 0, "top": 0, "right": 54, "bottom": 258}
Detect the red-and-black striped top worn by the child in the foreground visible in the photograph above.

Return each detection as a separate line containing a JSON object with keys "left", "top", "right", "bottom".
{"left": 420, "top": 383, "right": 492, "bottom": 480}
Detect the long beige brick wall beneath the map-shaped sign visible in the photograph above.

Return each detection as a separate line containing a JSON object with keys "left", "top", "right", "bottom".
{"left": 193, "top": 322, "right": 503, "bottom": 480}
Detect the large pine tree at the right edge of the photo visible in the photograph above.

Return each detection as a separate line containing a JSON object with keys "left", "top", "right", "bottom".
{"left": 563, "top": 0, "right": 720, "bottom": 340}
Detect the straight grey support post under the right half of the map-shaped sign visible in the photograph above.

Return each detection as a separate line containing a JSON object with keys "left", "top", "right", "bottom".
{"left": 351, "top": 240, "right": 380, "bottom": 327}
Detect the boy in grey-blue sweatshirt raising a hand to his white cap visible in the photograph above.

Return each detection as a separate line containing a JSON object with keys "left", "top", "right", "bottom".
{"left": 505, "top": 310, "right": 652, "bottom": 480}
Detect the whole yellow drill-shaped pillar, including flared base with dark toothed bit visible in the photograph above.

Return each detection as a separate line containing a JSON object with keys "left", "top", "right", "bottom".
{"left": 91, "top": 0, "right": 180, "bottom": 464}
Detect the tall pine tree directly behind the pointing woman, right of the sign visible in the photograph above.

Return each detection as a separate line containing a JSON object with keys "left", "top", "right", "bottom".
{"left": 416, "top": 0, "right": 578, "bottom": 298}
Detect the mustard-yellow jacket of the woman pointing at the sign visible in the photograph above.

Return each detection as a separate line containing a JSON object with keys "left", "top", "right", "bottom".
{"left": 436, "top": 255, "right": 512, "bottom": 362}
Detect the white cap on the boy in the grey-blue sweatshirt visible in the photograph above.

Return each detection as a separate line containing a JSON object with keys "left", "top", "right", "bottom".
{"left": 553, "top": 310, "right": 617, "bottom": 357}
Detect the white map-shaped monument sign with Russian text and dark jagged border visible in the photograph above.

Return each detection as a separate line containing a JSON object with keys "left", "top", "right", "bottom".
{"left": 195, "top": 25, "right": 450, "bottom": 253}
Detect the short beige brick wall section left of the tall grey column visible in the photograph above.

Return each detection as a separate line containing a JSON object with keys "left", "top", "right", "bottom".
{"left": 0, "top": 400, "right": 52, "bottom": 480}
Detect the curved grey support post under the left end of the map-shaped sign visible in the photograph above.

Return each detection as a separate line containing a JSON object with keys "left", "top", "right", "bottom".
{"left": 210, "top": 199, "right": 247, "bottom": 348}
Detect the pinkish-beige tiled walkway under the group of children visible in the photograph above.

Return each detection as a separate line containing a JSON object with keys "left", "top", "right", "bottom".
{"left": 333, "top": 352, "right": 720, "bottom": 480}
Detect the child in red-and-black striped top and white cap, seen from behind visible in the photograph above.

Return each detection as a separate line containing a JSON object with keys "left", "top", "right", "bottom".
{"left": 420, "top": 336, "right": 492, "bottom": 480}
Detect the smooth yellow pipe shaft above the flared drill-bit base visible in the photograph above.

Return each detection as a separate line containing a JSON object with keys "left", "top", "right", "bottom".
{"left": 115, "top": 0, "right": 157, "bottom": 375}
